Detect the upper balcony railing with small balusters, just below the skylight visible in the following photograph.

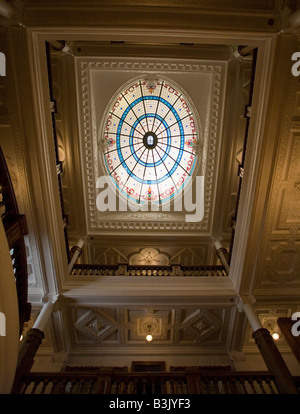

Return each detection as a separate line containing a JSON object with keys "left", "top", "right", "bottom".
{"left": 72, "top": 264, "right": 227, "bottom": 277}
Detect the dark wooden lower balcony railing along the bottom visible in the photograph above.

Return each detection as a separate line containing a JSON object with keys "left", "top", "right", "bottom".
{"left": 19, "top": 371, "right": 300, "bottom": 395}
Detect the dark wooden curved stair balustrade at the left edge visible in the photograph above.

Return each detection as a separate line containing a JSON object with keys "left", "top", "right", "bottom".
{"left": 0, "top": 147, "right": 31, "bottom": 334}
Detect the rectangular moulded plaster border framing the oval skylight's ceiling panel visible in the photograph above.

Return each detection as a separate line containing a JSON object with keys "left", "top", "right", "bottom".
{"left": 77, "top": 58, "right": 225, "bottom": 231}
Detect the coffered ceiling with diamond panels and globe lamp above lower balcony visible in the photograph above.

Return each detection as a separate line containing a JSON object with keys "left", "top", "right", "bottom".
{"left": 63, "top": 307, "right": 235, "bottom": 352}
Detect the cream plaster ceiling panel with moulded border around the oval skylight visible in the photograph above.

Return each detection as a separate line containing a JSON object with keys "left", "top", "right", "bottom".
{"left": 77, "top": 58, "right": 226, "bottom": 233}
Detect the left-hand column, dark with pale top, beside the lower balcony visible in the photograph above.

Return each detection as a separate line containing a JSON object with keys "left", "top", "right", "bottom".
{"left": 11, "top": 295, "right": 58, "bottom": 394}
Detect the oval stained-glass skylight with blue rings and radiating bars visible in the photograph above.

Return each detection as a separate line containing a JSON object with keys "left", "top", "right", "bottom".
{"left": 101, "top": 79, "right": 198, "bottom": 204}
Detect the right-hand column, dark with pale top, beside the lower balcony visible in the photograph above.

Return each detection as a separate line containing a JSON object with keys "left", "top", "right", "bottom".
{"left": 240, "top": 297, "right": 298, "bottom": 394}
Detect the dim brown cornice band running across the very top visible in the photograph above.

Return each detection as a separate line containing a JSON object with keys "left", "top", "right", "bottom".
{"left": 23, "top": 0, "right": 281, "bottom": 32}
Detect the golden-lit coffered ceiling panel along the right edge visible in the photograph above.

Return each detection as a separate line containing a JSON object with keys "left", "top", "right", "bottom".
{"left": 256, "top": 68, "right": 300, "bottom": 294}
